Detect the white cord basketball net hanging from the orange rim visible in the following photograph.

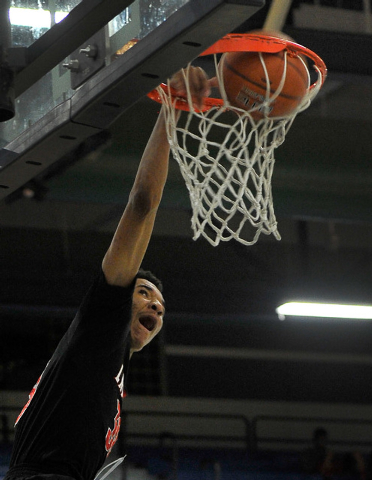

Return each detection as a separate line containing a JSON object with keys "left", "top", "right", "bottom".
{"left": 158, "top": 54, "right": 321, "bottom": 246}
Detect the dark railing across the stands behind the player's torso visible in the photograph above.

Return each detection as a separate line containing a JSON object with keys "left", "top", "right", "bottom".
{"left": 0, "top": 406, "right": 372, "bottom": 452}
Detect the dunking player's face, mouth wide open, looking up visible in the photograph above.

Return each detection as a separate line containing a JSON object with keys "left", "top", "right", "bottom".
{"left": 130, "top": 278, "right": 165, "bottom": 353}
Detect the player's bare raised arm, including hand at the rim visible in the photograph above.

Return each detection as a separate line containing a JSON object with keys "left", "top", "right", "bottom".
{"left": 102, "top": 67, "right": 209, "bottom": 287}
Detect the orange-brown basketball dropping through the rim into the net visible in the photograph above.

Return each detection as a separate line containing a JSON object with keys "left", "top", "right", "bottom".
{"left": 219, "top": 32, "right": 309, "bottom": 119}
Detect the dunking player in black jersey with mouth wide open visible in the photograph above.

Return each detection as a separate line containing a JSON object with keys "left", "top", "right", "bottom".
{"left": 5, "top": 68, "right": 209, "bottom": 480}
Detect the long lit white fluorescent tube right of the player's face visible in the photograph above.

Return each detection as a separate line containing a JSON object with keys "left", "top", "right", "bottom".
{"left": 276, "top": 302, "right": 372, "bottom": 320}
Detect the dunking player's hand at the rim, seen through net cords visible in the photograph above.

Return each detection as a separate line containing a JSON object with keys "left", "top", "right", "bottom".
{"left": 170, "top": 66, "right": 215, "bottom": 109}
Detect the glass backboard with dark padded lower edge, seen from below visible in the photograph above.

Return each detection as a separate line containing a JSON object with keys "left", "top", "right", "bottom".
{"left": 0, "top": 0, "right": 265, "bottom": 199}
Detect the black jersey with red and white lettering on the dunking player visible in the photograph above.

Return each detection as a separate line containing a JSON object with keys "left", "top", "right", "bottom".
{"left": 7, "top": 272, "right": 135, "bottom": 480}
